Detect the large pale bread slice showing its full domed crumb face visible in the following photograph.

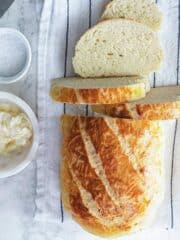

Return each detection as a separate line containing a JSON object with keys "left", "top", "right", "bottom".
{"left": 73, "top": 19, "right": 163, "bottom": 77}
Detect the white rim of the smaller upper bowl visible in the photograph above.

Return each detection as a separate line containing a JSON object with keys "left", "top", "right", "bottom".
{"left": 0, "top": 27, "right": 32, "bottom": 85}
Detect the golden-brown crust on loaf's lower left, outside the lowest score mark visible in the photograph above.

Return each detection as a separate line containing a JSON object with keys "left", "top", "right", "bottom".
{"left": 61, "top": 153, "right": 131, "bottom": 237}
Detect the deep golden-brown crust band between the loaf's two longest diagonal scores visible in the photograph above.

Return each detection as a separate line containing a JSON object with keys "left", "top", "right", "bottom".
{"left": 83, "top": 119, "right": 142, "bottom": 199}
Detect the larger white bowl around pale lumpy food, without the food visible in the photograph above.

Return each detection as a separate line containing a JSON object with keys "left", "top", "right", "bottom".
{"left": 0, "top": 92, "right": 39, "bottom": 178}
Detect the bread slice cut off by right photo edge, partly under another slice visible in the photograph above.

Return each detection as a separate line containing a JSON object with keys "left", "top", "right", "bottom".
{"left": 92, "top": 86, "right": 180, "bottom": 120}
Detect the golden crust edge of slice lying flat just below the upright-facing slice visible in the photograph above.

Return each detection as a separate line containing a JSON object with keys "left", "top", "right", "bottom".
{"left": 50, "top": 79, "right": 150, "bottom": 104}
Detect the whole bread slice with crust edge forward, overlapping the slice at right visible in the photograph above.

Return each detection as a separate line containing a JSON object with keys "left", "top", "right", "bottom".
{"left": 50, "top": 77, "right": 150, "bottom": 104}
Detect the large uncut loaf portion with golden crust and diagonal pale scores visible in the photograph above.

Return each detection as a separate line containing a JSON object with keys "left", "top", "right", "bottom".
{"left": 61, "top": 115, "right": 164, "bottom": 237}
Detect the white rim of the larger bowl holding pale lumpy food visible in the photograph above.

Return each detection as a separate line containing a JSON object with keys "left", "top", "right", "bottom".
{"left": 0, "top": 91, "right": 39, "bottom": 179}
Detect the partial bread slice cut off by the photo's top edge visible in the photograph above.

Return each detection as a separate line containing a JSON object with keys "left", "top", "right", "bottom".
{"left": 101, "top": 0, "right": 162, "bottom": 31}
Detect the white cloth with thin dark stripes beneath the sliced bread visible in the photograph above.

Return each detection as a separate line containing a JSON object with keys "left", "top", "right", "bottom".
{"left": 33, "top": 0, "right": 180, "bottom": 240}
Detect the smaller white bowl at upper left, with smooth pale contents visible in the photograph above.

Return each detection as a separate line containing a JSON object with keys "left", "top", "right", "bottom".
{"left": 0, "top": 28, "right": 32, "bottom": 84}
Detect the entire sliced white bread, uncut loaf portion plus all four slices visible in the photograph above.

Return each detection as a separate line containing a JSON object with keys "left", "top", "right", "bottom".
{"left": 51, "top": 0, "right": 180, "bottom": 236}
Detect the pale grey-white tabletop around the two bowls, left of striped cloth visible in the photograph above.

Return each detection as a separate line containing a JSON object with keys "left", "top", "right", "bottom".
{"left": 0, "top": 0, "right": 42, "bottom": 240}
